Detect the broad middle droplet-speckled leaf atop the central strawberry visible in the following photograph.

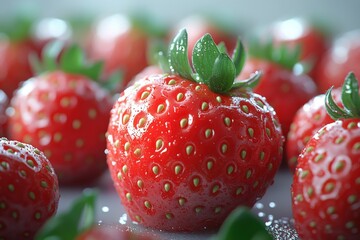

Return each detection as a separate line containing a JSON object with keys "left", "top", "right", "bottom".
{"left": 192, "top": 34, "right": 220, "bottom": 83}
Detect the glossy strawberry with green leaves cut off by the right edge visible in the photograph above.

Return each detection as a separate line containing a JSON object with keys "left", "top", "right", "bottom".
{"left": 292, "top": 73, "right": 360, "bottom": 240}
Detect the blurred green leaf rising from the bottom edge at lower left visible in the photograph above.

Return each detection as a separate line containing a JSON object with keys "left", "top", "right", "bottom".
{"left": 35, "top": 189, "right": 97, "bottom": 240}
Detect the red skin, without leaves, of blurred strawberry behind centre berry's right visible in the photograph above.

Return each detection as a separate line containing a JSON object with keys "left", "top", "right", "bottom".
{"left": 238, "top": 58, "right": 317, "bottom": 136}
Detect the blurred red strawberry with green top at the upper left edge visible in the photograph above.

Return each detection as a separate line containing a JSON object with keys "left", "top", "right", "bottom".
{"left": 0, "top": 17, "right": 71, "bottom": 97}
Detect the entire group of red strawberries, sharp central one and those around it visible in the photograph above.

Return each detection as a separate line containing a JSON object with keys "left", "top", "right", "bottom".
{"left": 0, "top": 14, "right": 360, "bottom": 239}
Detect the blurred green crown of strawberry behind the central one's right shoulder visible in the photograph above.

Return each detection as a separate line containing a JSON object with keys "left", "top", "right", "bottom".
{"left": 249, "top": 39, "right": 313, "bottom": 74}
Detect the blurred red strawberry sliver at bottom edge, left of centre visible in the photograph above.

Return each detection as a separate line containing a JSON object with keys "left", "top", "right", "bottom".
{"left": 76, "top": 225, "right": 155, "bottom": 240}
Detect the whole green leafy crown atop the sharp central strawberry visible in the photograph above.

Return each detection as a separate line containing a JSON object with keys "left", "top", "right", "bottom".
{"left": 164, "top": 29, "right": 261, "bottom": 94}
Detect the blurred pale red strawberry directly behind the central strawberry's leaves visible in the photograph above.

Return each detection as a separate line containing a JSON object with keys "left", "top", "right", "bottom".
{"left": 171, "top": 15, "right": 237, "bottom": 60}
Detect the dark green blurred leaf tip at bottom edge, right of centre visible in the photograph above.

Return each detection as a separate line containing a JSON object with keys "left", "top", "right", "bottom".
{"left": 213, "top": 207, "right": 273, "bottom": 240}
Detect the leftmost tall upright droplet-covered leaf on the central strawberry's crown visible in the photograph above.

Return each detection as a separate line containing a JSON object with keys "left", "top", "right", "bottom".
{"left": 169, "top": 29, "right": 195, "bottom": 80}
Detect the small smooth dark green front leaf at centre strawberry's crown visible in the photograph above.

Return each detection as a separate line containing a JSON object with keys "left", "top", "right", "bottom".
{"left": 209, "top": 53, "right": 236, "bottom": 93}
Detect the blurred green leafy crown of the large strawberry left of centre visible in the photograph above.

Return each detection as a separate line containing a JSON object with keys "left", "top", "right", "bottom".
{"left": 30, "top": 40, "right": 121, "bottom": 90}
